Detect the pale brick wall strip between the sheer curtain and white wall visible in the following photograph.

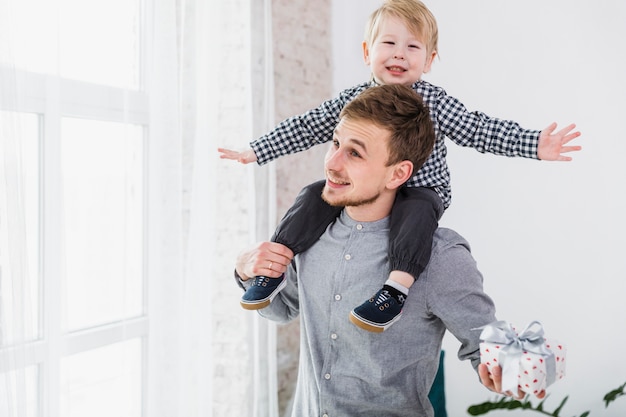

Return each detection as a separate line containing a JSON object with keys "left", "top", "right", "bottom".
{"left": 273, "top": 0, "right": 332, "bottom": 415}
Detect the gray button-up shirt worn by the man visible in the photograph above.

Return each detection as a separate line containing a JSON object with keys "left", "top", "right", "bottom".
{"left": 241, "top": 210, "right": 495, "bottom": 417}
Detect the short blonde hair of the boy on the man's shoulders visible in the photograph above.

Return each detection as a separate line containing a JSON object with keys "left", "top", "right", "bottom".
{"left": 365, "top": 0, "right": 439, "bottom": 54}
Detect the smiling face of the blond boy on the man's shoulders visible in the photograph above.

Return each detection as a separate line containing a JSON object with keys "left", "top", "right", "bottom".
{"left": 363, "top": 16, "right": 436, "bottom": 85}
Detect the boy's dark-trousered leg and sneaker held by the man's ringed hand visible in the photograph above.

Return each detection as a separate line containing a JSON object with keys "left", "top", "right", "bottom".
{"left": 240, "top": 180, "right": 342, "bottom": 310}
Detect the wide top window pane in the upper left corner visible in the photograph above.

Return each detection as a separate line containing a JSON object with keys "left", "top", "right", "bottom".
{"left": 0, "top": 0, "right": 140, "bottom": 89}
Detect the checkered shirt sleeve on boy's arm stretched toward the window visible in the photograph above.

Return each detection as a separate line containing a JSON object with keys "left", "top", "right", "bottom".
{"left": 250, "top": 83, "right": 367, "bottom": 165}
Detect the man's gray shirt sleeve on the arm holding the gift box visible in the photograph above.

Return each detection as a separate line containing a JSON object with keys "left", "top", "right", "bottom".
{"left": 420, "top": 231, "right": 496, "bottom": 369}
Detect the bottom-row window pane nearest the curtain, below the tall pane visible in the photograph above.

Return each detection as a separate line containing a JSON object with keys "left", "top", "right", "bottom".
{"left": 61, "top": 339, "right": 142, "bottom": 417}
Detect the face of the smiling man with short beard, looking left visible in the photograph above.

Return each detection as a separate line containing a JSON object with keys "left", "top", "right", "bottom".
{"left": 322, "top": 114, "right": 395, "bottom": 221}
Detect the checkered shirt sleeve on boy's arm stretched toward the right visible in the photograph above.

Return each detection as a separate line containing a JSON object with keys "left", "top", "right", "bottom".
{"left": 436, "top": 90, "right": 541, "bottom": 159}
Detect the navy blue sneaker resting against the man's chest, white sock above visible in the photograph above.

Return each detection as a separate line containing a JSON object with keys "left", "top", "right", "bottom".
{"left": 350, "top": 288, "right": 404, "bottom": 333}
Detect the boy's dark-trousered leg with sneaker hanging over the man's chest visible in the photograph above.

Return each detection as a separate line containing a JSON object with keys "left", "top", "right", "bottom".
{"left": 350, "top": 187, "right": 443, "bottom": 332}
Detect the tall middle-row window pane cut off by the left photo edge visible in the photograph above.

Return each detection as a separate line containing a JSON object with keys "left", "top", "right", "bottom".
{"left": 0, "top": 111, "right": 40, "bottom": 346}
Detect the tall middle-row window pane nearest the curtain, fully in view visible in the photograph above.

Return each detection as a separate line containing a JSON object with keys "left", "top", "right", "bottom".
{"left": 61, "top": 118, "right": 144, "bottom": 331}
